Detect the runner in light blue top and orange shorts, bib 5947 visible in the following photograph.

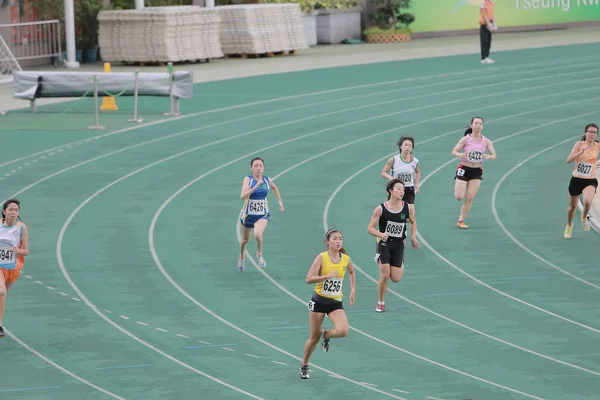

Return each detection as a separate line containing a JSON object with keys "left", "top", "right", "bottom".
{"left": 0, "top": 199, "right": 29, "bottom": 338}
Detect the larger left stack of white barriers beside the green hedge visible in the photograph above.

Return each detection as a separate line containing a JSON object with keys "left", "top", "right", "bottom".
{"left": 98, "top": 6, "right": 224, "bottom": 63}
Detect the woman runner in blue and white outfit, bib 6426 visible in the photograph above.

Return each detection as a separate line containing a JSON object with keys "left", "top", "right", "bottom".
{"left": 238, "top": 157, "right": 283, "bottom": 271}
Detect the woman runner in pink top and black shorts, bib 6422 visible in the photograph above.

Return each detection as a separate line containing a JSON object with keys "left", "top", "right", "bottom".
{"left": 452, "top": 117, "right": 496, "bottom": 229}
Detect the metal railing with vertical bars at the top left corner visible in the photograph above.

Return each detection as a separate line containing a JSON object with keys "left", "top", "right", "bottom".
{"left": 0, "top": 20, "right": 62, "bottom": 60}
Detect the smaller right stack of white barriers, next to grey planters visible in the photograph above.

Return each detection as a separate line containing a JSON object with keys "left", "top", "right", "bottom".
{"left": 215, "top": 3, "right": 308, "bottom": 55}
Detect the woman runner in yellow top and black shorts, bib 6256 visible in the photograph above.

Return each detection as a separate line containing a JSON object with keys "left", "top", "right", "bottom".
{"left": 300, "top": 229, "right": 356, "bottom": 379}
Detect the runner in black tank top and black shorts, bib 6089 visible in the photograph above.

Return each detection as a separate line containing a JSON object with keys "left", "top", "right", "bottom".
{"left": 368, "top": 179, "right": 421, "bottom": 312}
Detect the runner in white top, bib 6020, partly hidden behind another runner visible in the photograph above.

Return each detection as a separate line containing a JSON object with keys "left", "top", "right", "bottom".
{"left": 381, "top": 136, "right": 421, "bottom": 209}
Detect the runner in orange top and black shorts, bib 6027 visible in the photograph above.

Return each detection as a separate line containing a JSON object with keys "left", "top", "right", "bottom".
{"left": 564, "top": 124, "right": 600, "bottom": 239}
